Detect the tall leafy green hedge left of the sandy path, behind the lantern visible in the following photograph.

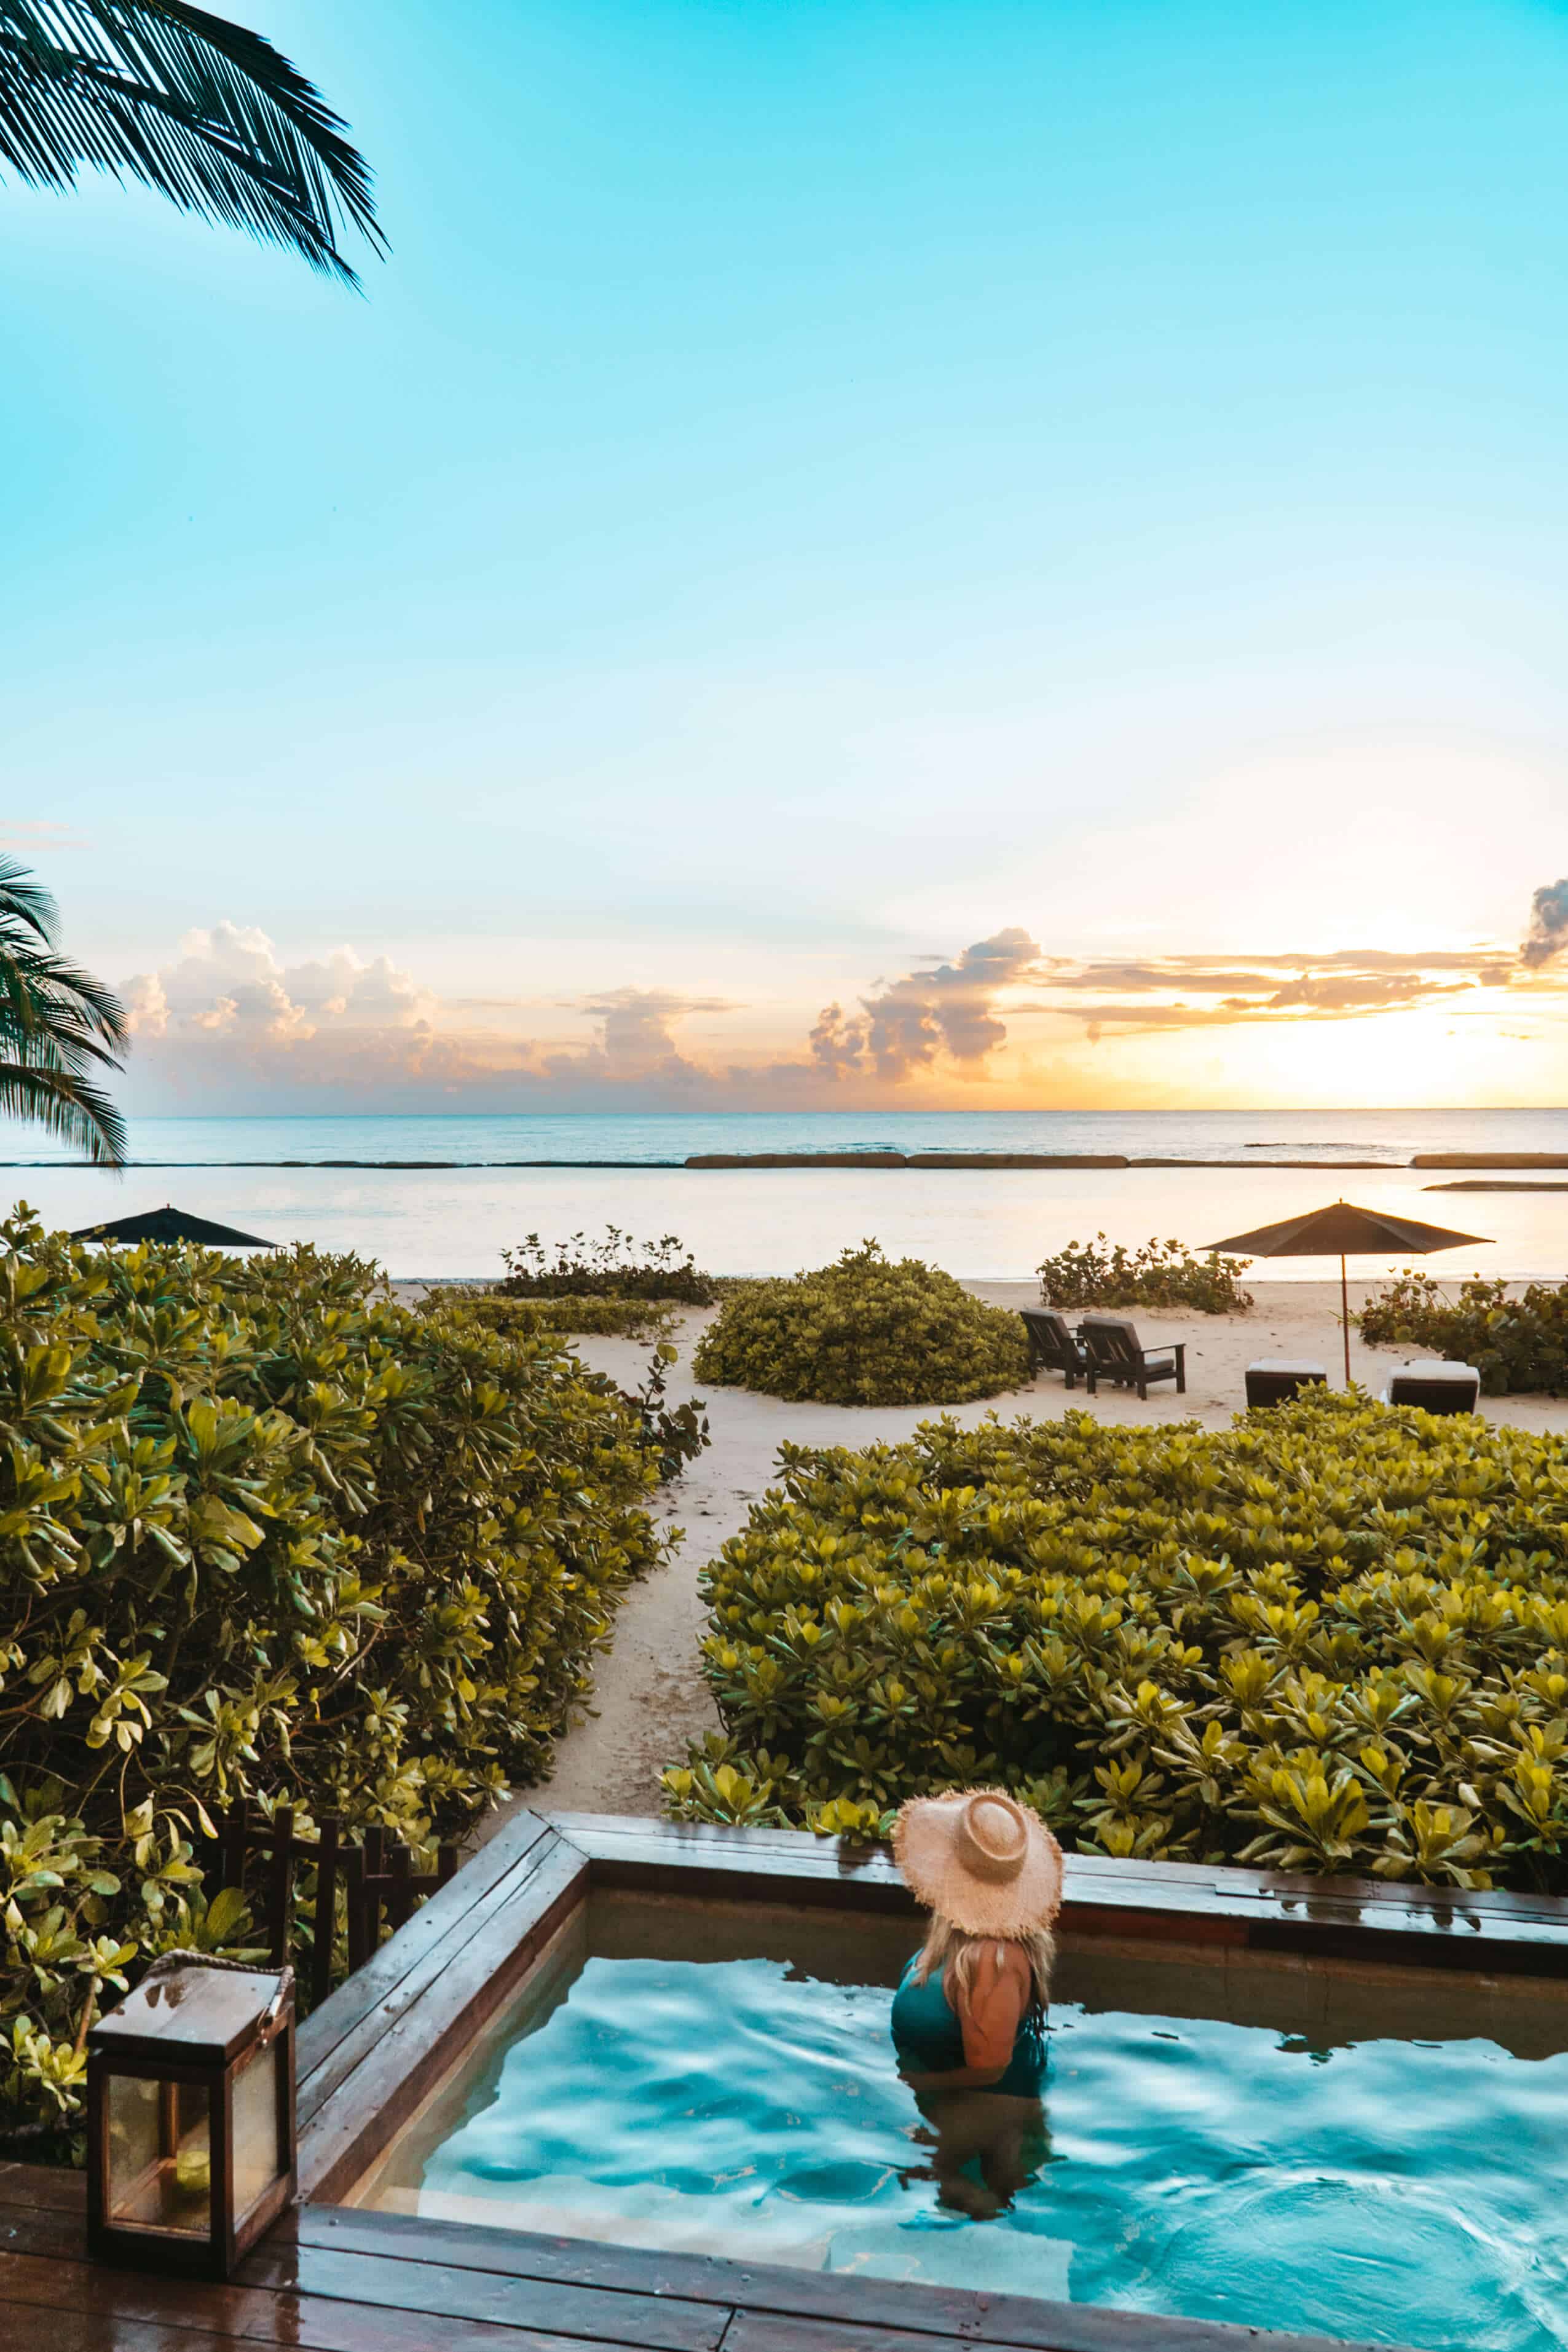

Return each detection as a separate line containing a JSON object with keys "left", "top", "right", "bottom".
{"left": 0, "top": 1211, "right": 689, "bottom": 2145}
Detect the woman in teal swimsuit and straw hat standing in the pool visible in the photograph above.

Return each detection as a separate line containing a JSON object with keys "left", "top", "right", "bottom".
{"left": 893, "top": 1788, "right": 1063, "bottom": 2216}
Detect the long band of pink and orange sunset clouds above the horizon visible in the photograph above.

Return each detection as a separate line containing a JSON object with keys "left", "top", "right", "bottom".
{"left": 122, "top": 882, "right": 1568, "bottom": 1110}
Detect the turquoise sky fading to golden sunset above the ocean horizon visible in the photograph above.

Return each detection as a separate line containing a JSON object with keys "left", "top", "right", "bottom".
{"left": 0, "top": 0, "right": 1568, "bottom": 1115}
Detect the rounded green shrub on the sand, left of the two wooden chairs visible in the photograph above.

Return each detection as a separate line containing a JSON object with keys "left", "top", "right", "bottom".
{"left": 691, "top": 1242, "right": 1030, "bottom": 1404}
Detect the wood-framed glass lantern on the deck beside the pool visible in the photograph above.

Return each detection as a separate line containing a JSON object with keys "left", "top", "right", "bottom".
{"left": 87, "top": 1952, "right": 294, "bottom": 2279}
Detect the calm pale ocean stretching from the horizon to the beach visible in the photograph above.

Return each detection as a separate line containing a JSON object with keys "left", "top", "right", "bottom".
{"left": 12, "top": 1110, "right": 1568, "bottom": 1279}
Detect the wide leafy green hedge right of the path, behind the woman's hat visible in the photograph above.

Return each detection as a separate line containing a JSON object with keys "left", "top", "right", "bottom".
{"left": 663, "top": 1390, "right": 1568, "bottom": 1893}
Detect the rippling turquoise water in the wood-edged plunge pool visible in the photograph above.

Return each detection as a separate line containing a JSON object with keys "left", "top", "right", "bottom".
{"left": 360, "top": 1903, "right": 1568, "bottom": 2352}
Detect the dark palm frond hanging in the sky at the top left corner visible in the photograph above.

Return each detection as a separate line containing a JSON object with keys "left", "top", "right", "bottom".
{"left": 0, "top": 0, "right": 385, "bottom": 287}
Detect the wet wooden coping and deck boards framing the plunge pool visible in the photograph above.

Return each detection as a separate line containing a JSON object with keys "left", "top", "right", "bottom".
{"left": 12, "top": 1811, "right": 1568, "bottom": 2352}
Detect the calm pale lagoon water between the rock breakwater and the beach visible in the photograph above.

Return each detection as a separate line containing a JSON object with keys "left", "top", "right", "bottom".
{"left": 7, "top": 1167, "right": 1568, "bottom": 1282}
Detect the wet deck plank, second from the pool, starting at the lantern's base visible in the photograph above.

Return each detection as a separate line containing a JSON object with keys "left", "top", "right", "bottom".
{"left": 240, "top": 2239, "right": 729, "bottom": 2352}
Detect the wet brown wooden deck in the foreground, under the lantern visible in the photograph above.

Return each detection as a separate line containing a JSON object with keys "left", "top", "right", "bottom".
{"left": 0, "top": 2164, "right": 1387, "bottom": 2352}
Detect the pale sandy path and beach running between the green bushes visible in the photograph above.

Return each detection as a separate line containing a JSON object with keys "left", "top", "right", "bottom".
{"left": 491, "top": 1282, "right": 1568, "bottom": 1813}
